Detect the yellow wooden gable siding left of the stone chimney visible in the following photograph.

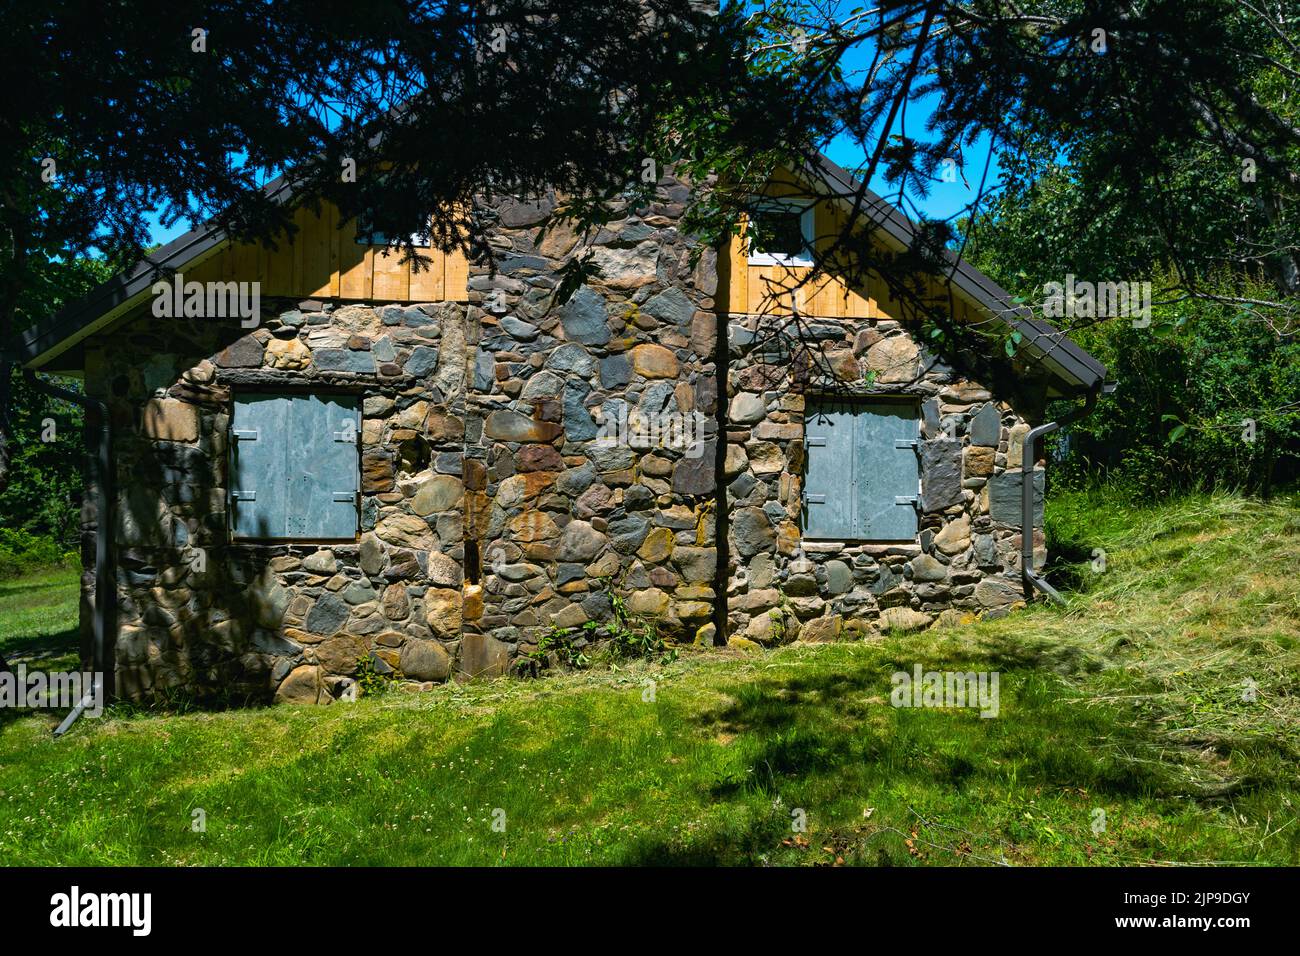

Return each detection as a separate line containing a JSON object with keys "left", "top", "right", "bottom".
{"left": 186, "top": 203, "right": 469, "bottom": 302}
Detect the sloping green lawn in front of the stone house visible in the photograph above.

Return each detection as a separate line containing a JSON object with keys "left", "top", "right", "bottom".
{"left": 0, "top": 496, "right": 1300, "bottom": 865}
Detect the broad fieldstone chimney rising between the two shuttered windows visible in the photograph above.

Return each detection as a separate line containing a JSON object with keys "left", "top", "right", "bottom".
{"left": 464, "top": 178, "right": 718, "bottom": 670}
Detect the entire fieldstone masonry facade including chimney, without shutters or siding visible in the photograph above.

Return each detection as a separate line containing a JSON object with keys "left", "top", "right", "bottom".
{"left": 83, "top": 170, "right": 1041, "bottom": 702}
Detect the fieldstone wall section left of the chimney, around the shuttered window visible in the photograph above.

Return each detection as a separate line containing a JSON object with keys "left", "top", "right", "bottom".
{"left": 86, "top": 295, "right": 468, "bottom": 701}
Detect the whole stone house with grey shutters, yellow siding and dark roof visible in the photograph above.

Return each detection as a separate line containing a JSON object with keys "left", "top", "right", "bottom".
{"left": 17, "top": 153, "right": 1105, "bottom": 701}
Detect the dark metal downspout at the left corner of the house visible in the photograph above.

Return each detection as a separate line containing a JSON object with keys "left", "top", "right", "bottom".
{"left": 23, "top": 369, "right": 117, "bottom": 736}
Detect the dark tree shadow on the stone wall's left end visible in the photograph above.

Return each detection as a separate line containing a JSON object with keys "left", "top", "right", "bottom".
{"left": 105, "top": 310, "right": 319, "bottom": 705}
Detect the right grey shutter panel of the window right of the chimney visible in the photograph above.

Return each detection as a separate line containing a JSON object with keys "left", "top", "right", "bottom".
{"left": 853, "top": 402, "right": 920, "bottom": 541}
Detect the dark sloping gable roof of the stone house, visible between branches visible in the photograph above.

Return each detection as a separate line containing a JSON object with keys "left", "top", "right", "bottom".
{"left": 10, "top": 153, "right": 1106, "bottom": 395}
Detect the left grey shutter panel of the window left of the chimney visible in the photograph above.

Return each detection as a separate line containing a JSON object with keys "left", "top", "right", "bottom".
{"left": 230, "top": 394, "right": 290, "bottom": 538}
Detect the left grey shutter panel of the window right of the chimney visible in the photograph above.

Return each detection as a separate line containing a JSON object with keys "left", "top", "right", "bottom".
{"left": 803, "top": 405, "right": 857, "bottom": 538}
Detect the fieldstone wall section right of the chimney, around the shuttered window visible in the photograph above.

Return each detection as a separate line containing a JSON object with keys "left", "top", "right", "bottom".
{"left": 727, "top": 316, "right": 1045, "bottom": 644}
